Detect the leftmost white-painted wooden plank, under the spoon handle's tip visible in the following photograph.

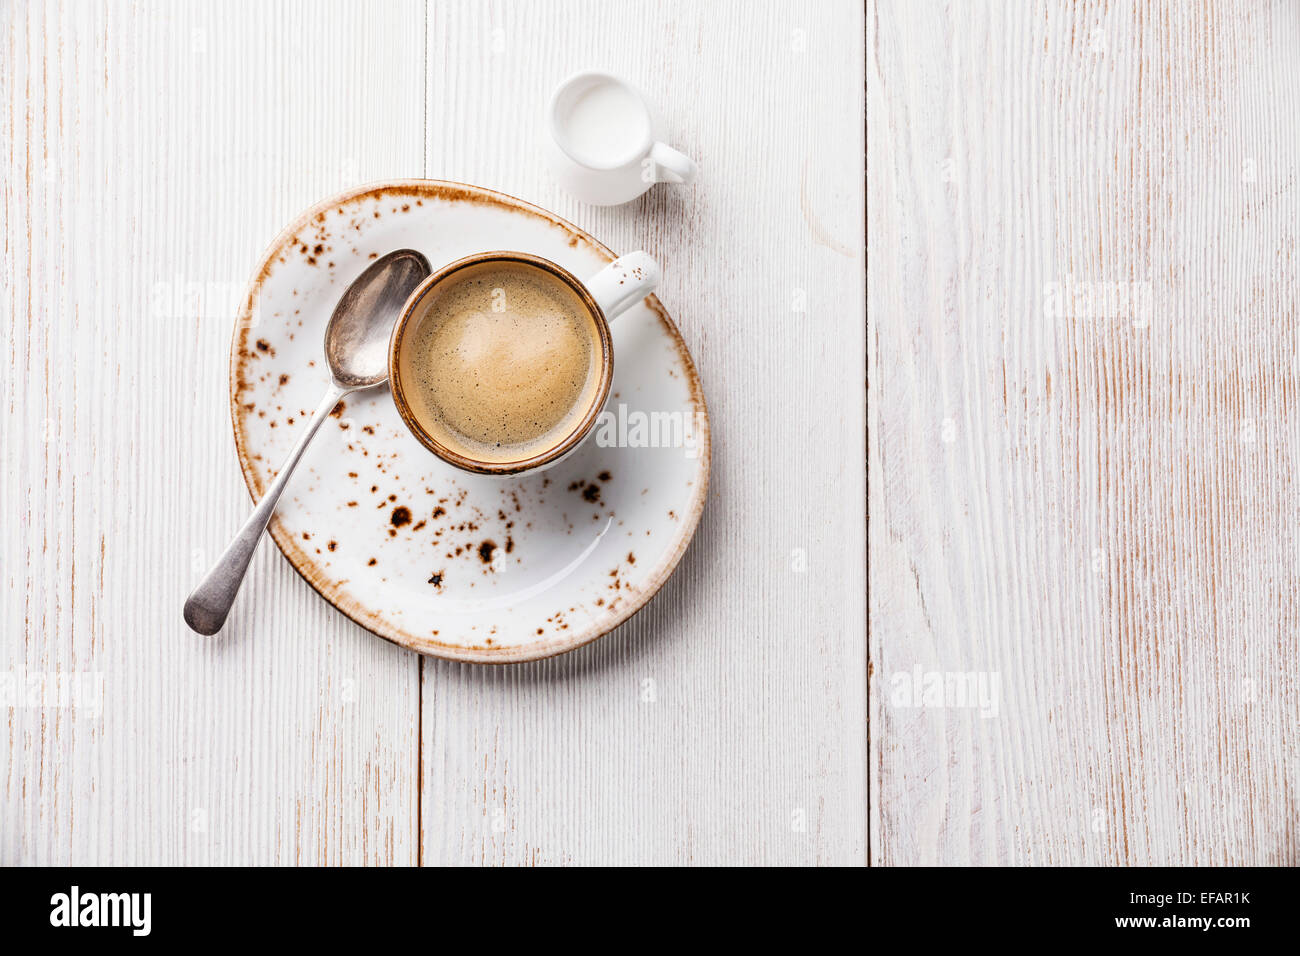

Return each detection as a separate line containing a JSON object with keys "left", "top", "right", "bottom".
{"left": 0, "top": 0, "right": 424, "bottom": 864}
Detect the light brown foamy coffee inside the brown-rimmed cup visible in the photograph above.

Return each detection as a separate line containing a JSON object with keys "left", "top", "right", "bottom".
{"left": 400, "top": 263, "right": 602, "bottom": 464}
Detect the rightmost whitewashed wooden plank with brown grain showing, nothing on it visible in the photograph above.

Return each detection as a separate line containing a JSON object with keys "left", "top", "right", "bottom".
{"left": 867, "top": 0, "right": 1300, "bottom": 864}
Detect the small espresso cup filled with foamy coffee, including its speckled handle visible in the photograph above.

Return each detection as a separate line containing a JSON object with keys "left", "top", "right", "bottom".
{"left": 389, "top": 252, "right": 659, "bottom": 476}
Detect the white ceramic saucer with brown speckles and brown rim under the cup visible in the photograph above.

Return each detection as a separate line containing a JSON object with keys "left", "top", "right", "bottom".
{"left": 230, "top": 179, "right": 710, "bottom": 663}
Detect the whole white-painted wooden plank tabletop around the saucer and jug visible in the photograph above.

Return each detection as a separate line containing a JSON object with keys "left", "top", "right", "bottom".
{"left": 10, "top": 0, "right": 1300, "bottom": 864}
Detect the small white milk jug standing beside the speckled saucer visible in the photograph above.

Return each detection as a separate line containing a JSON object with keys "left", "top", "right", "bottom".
{"left": 546, "top": 70, "right": 697, "bottom": 206}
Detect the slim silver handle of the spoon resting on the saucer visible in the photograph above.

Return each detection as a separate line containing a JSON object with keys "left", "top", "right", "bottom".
{"left": 185, "top": 382, "right": 352, "bottom": 635}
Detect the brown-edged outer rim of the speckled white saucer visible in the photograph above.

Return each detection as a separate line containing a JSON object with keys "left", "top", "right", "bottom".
{"left": 230, "top": 179, "right": 712, "bottom": 663}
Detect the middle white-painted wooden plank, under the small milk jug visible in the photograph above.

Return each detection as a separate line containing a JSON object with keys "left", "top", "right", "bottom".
{"left": 421, "top": 1, "right": 866, "bottom": 864}
